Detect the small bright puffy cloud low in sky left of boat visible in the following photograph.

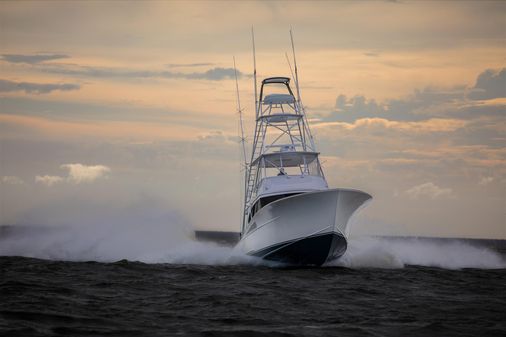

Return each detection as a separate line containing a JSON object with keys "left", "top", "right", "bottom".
{"left": 35, "top": 163, "right": 111, "bottom": 187}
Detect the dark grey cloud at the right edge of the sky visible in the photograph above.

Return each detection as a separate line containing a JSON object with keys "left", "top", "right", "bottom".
{"left": 468, "top": 68, "right": 506, "bottom": 100}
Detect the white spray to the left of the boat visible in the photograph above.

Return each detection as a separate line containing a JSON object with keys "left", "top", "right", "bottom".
{"left": 0, "top": 222, "right": 247, "bottom": 265}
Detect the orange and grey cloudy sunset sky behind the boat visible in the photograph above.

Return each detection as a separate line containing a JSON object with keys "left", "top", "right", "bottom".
{"left": 0, "top": 1, "right": 506, "bottom": 239}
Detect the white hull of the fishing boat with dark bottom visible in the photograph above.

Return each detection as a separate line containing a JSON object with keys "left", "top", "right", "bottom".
{"left": 236, "top": 189, "right": 371, "bottom": 265}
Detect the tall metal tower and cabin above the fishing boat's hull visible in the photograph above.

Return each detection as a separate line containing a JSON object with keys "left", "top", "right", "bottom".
{"left": 242, "top": 77, "right": 328, "bottom": 232}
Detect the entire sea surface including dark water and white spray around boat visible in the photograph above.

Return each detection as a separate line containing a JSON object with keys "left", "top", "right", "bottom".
{"left": 0, "top": 224, "right": 506, "bottom": 336}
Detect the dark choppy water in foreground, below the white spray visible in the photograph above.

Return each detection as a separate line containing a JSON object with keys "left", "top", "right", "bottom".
{"left": 0, "top": 257, "right": 506, "bottom": 336}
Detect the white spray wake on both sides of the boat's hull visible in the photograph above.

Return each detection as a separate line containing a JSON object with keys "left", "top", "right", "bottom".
{"left": 0, "top": 225, "right": 506, "bottom": 269}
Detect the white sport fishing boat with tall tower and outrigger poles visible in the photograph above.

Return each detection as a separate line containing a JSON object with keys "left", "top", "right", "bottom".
{"left": 234, "top": 32, "right": 371, "bottom": 266}
